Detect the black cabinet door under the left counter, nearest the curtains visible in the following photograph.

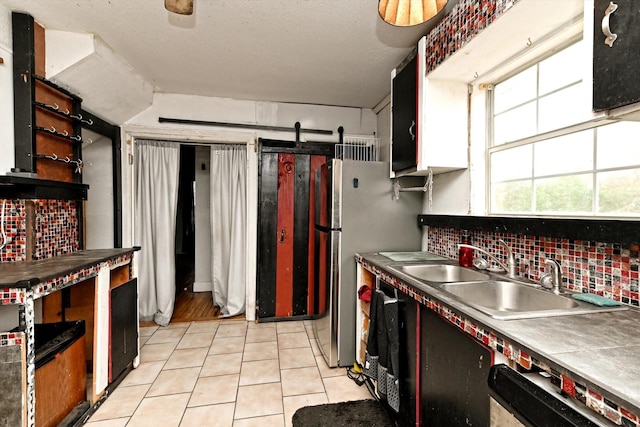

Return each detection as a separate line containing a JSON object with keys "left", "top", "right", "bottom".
{"left": 109, "top": 279, "right": 138, "bottom": 382}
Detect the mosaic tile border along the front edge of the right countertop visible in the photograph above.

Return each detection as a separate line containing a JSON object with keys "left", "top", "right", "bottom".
{"left": 356, "top": 255, "right": 640, "bottom": 427}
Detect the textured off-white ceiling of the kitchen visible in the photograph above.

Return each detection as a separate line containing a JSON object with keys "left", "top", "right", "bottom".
{"left": 3, "top": 0, "right": 440, "bottom": 108}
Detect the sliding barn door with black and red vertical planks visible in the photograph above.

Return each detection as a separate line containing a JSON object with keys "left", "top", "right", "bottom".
{"left": 257, "top": 140, "right": 333, "bottom": 320}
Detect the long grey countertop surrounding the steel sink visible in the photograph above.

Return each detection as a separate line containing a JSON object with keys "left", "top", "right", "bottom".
{"left": 359, "top": 253, "right": 640, "bottom": 414}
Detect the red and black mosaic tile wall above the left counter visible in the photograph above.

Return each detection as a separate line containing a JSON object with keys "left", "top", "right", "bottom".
{"left": 0, "top": 200, "right": 80, "bottom": 262}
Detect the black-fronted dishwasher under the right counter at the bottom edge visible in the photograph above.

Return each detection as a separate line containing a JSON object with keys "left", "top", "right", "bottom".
{"left": 489, "top": 364, "right": 608, "bottom": 427}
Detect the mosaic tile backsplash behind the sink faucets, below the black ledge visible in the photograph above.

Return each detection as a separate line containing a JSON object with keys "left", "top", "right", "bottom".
{"left": 427, "top": 227, "right": 640, "bottom": 307}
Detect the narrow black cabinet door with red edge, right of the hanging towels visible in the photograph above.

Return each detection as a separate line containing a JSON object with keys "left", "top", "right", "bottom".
{"left": 380, "top": 282, "right": 419, "bottom": 426}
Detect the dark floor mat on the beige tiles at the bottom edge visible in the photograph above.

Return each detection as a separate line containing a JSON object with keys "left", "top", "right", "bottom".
{"left": 293, "top": 400, "right": 396, "bottom": 427}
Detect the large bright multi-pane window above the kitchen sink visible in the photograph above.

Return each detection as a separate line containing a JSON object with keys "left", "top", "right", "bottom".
{"left": 489, "top": 41, "right": 640, "bottom": 217}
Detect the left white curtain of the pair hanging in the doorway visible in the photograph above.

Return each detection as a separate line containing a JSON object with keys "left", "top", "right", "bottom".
{"left": 135, "top": 141, "right": 180, "bottom": 326}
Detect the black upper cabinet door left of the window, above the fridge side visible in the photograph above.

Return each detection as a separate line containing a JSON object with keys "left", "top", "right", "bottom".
{"left": 391, "top": 56, "right": 418, "bottom": 171}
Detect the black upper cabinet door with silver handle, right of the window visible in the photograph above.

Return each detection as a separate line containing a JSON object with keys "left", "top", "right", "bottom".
{"left": 593, "top": 0, "right": 640, "bottom": 111}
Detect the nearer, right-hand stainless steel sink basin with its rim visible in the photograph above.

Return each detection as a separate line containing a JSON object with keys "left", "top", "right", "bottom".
{"left": 438, "top": 280, "right": 626, "bottom": 320}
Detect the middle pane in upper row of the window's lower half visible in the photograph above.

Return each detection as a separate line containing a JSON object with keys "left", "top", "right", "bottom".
{"left": 532, "top": 129, "right": 593, "bottom": 177}
